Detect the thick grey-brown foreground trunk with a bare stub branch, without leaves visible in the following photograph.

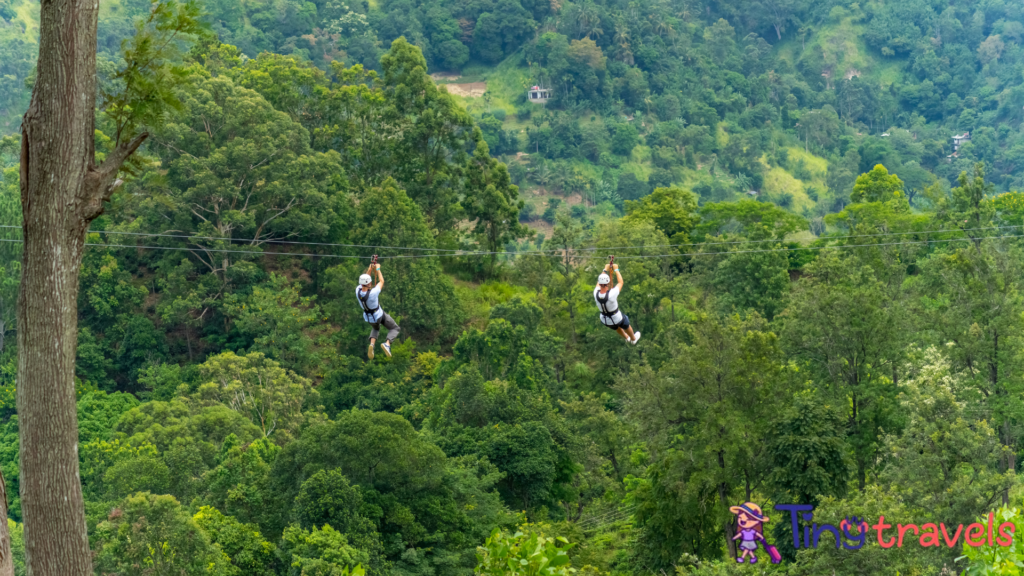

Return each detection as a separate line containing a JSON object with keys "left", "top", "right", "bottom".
{"left": 17, "top": 0, "right": 145, "bottom": 576}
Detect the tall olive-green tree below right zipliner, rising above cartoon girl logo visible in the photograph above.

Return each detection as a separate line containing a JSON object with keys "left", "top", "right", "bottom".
{"left": 618, "top": 315, "right": 786, "bottom": 567}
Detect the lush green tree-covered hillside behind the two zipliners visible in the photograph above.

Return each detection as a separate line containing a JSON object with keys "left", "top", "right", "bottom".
{"left": 0, "top": 0, "right": 1024, "bottom": 576}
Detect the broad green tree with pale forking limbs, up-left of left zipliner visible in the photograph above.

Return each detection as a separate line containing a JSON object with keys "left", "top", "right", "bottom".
{"left": 148, "top": 74, "right": 344, "bottom": 281}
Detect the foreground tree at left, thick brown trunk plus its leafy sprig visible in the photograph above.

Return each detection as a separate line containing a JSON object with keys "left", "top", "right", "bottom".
{"left": 17, "top": 0, "right": 205, "bottom": 565}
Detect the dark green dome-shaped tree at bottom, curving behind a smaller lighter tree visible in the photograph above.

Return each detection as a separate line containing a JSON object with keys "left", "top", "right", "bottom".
{"left": 265, "top": 410, "right": 498, "bottom": 571}
